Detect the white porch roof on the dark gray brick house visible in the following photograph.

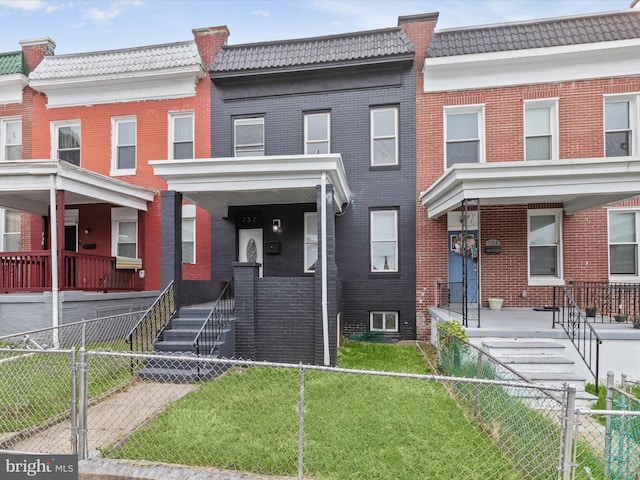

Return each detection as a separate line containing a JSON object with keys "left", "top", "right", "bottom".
{"left": 149, "top": 154, "right": 351, "bottom": 216}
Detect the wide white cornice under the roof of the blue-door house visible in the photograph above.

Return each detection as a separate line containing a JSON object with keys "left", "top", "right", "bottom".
{"left": 423, "top": 39, "right": 640, "bottom": 93}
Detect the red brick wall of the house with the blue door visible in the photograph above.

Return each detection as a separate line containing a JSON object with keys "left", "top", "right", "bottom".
{"left": 416, "top": 77, "right": 640, "bottom": 338}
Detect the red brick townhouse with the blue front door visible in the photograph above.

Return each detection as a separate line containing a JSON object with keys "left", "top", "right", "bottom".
{"left": 416, "top": 8, "right": 640, "bottom": 337}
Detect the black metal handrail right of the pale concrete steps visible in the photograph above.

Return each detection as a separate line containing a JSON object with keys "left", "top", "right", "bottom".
{"left": 553, "top": 286, "right": 602, "bottom": 392}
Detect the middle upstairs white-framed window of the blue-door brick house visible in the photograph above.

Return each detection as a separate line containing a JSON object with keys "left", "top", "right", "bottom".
{"left": 524, "top": 99, "right": 558, "bottom": 160}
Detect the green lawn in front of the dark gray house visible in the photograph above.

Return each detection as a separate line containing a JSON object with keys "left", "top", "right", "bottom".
{"left": 104, "top": 343, "right": 523, "bottom": 480}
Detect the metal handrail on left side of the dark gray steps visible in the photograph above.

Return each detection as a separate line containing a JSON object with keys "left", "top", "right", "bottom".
{"left": 126, "top": 281, "right": 176, "bottom": 352}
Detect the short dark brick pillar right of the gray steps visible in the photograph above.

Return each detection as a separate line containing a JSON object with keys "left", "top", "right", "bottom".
{"left": 233, "top": 262, "right": 260, "bottom": 359}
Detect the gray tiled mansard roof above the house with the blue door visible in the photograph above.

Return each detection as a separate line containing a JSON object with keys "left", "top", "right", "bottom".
{"left": 427, "top": 10, "right": 640, "bottom": 58}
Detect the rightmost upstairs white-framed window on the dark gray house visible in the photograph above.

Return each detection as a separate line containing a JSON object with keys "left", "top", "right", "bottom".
{"left": 370, "top": 107, "right": 399, "bottom": 167}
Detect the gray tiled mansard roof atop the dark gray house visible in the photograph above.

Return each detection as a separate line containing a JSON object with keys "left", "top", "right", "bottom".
{"left": 210, "top": 27, "right": 414, "bottom": 78}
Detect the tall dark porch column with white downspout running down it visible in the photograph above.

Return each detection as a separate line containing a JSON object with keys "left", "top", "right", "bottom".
{"left": 314, "top": 184, "right": 339, "bottom": 365}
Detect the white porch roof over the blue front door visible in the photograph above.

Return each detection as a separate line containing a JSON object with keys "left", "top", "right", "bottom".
{"left": 420, "top": 157, "right": 640, "bottom": 218}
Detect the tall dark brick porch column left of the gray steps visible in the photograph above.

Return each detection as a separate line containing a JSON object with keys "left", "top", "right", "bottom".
{"left": 160, "top": 190, "right": 182, "bottom": 309}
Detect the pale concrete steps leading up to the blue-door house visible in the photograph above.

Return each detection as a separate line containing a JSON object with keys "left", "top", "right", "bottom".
{"left": 482, "top": 338, "right": 597, "bottom": 406}
